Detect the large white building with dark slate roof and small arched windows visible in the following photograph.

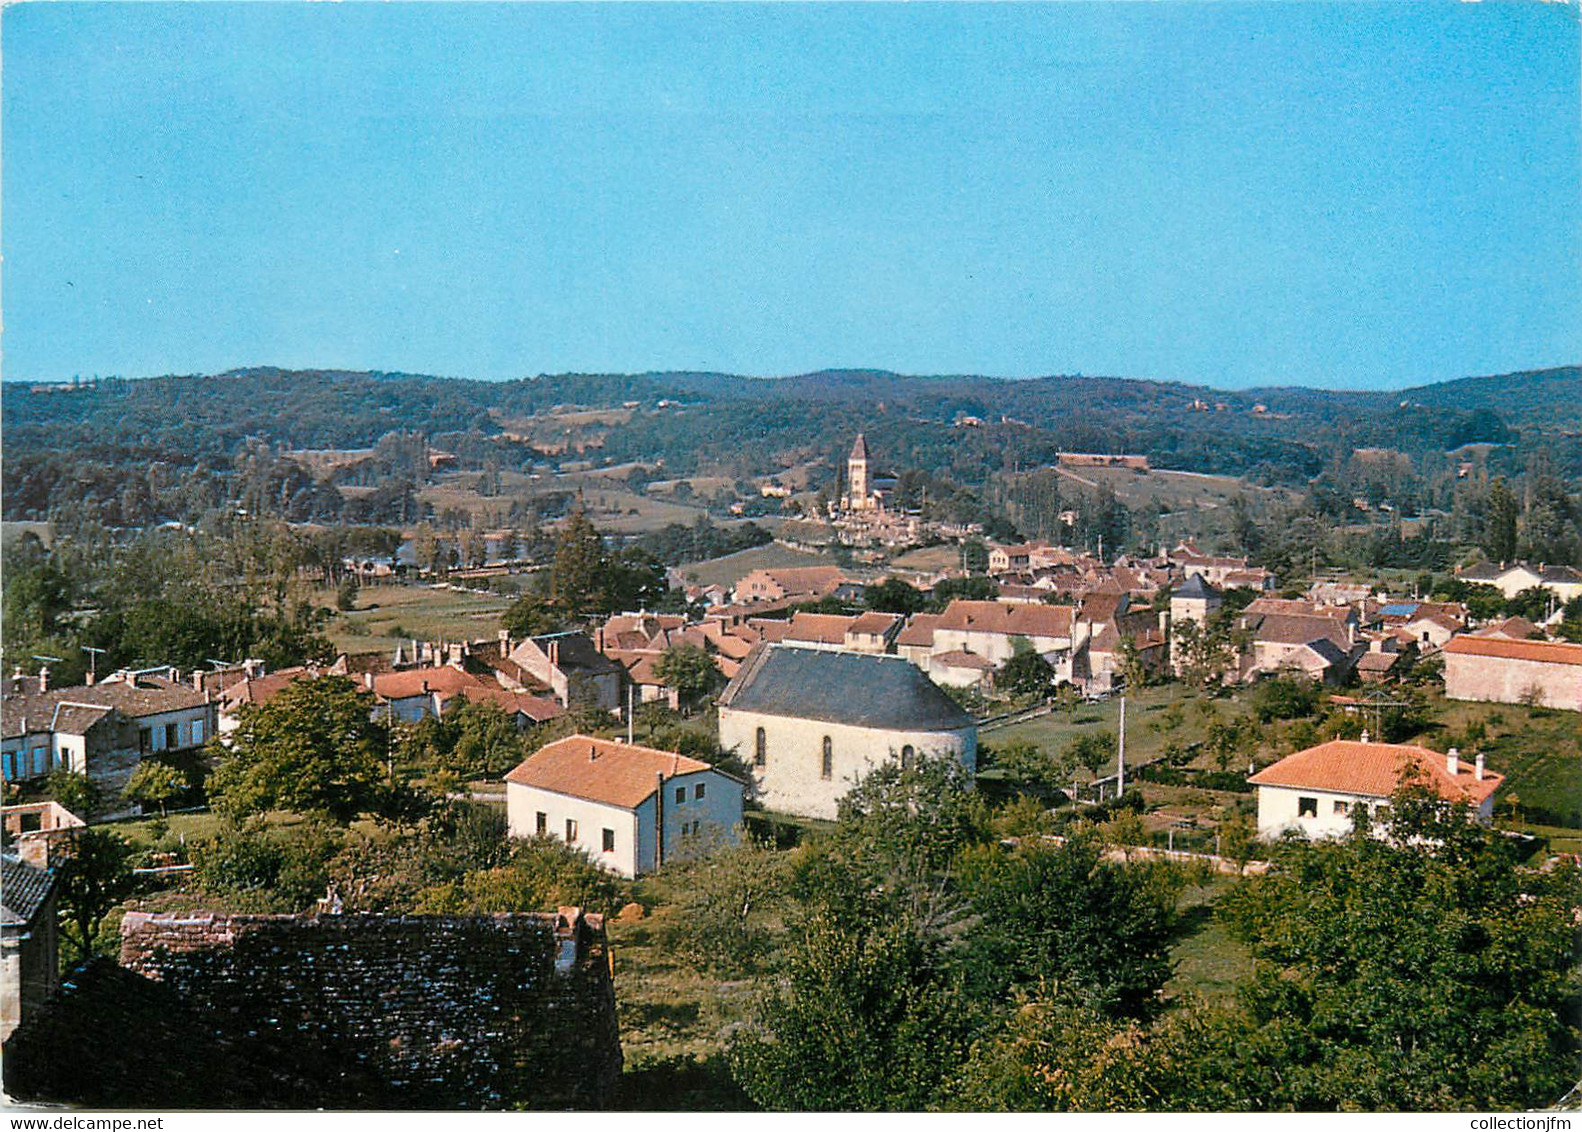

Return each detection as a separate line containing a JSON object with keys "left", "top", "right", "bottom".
{"left": 720, "top": 645, "right": 978, "bottom": 819}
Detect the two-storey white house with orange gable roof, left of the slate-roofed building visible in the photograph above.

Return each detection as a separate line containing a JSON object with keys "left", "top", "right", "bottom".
{"left": 505, "top": 735, "right": 742, "bottom": 877}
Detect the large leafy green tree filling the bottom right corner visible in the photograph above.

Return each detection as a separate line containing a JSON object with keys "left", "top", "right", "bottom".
{"left": 1221, "top": 784, "right": 1582, "bottom": 1111}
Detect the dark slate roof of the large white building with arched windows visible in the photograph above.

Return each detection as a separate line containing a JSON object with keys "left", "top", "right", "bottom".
{"left": 720, "top": 645, "right": 975, "bottom": 730}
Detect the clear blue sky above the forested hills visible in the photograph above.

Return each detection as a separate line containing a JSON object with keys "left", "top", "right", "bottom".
{"left": 0, "top": 3, "right": 1582, "bottom": 387}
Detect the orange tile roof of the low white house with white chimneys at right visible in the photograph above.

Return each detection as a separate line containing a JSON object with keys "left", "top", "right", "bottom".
{"left": 1247, "top": 738, "right": 1504, "bottom": 806}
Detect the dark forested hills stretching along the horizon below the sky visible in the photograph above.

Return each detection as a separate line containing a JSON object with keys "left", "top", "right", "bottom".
{"left": 0, "top": 367, "right": 1582, "bottom": 517}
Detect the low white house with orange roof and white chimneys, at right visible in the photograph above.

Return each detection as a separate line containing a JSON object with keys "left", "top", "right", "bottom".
{"left": 1247, "top": 734, "right": 1504, "bottom": 838}
